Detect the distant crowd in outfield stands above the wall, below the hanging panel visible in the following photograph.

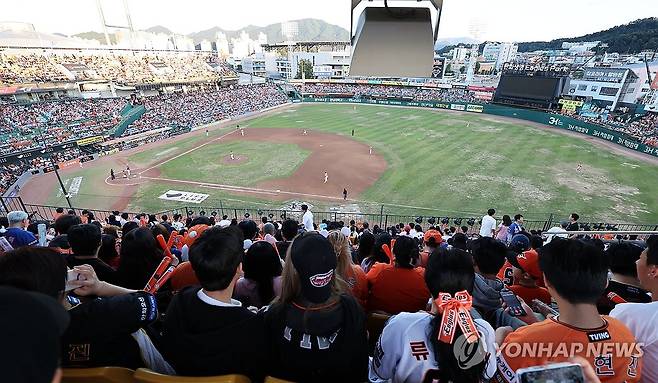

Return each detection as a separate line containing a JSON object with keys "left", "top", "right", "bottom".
{"left": 297, "top": 83, "right": 476, "bottom": 102}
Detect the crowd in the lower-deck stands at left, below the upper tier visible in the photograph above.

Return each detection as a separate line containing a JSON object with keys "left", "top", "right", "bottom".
{"left": 0, "top": 84, "right": 288, "bottom": 193}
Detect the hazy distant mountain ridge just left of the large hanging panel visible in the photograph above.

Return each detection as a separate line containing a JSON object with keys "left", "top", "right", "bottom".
{"left": 189, "top": 19, "right": 349, "bottom": 44}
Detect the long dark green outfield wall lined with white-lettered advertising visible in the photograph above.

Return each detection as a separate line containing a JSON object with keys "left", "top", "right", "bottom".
{"left": 304, "top": 97, "right": 658, "bottom": 157}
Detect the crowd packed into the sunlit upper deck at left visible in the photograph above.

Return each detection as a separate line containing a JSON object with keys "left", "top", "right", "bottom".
{"left": 0, "top": 51, "right": 235, "bottom": 85}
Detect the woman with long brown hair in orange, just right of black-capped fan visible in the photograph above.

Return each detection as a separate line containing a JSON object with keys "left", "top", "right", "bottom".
{"left": 327, "top": 230, "right": 368, "bottom": 307}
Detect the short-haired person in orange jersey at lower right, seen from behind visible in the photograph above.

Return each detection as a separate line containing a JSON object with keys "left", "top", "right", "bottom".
{"left": 494, "top": 238, "right": 642, "bottom": 383}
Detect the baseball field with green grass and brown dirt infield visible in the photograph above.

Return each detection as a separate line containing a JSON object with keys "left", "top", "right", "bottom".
{"left": 23, "top": 104, "right": 658, "bottom": 224}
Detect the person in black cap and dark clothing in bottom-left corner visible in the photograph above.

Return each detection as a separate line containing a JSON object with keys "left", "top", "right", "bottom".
{"left": 0, "top": 287, "right": 69, "bottom": 383}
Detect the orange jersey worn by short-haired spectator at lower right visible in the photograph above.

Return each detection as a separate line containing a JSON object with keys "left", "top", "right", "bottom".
{"left": 493, "top": 316, "right": 642, "bottom": 383}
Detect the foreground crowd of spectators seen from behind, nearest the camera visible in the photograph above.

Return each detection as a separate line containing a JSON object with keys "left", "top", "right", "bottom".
{"left": 0, "top": 206, "right": 658, "bottom": 383}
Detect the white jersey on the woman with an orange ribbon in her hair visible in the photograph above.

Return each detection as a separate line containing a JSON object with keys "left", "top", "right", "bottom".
{"left": 368, "top": 312, "right": 496, "bottom": 383}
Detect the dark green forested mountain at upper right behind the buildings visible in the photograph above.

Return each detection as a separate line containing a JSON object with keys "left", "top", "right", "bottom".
{"left": 519, "top": 17, "right": 658, "bottom": 54}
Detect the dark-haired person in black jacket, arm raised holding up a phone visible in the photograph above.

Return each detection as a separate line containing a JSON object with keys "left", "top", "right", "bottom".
{"left": 0, "top": 247, "right": 173, "bottom": 373}
